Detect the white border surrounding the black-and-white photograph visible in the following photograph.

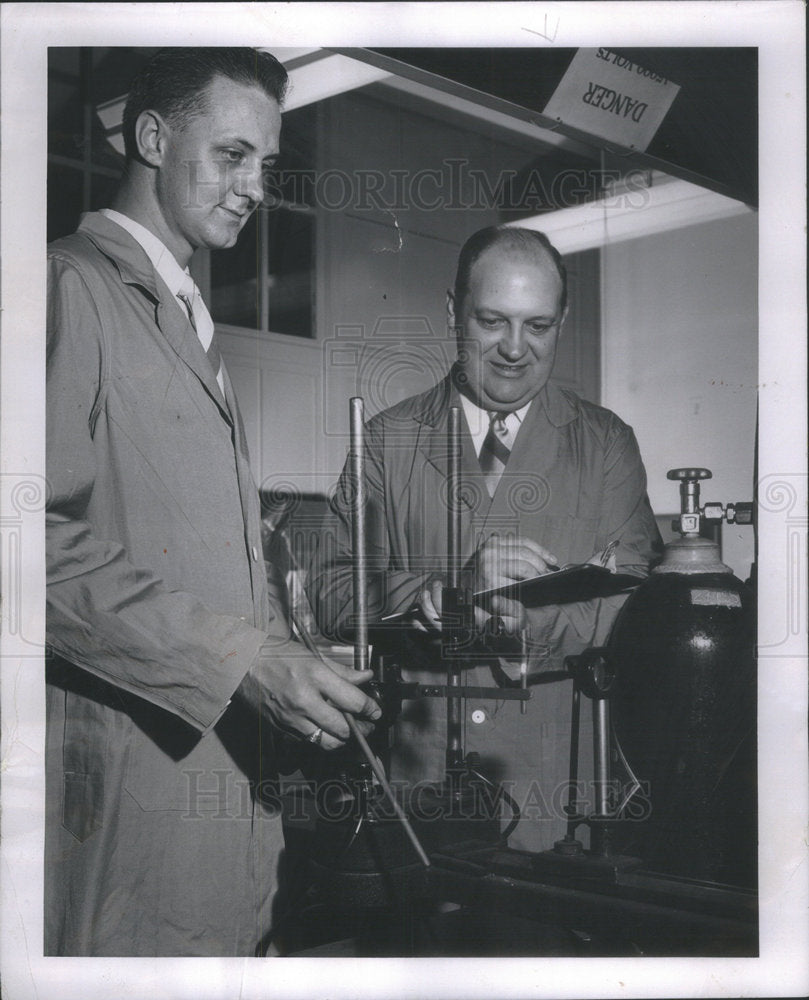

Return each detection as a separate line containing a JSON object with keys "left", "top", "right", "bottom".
{"left": 0, "top": 0, "right": 809, "bottom": 1000}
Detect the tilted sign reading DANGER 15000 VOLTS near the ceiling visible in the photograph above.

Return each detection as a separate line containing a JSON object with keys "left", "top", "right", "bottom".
{"left": 543, "top": 49, "right": 680, "bottom": 152}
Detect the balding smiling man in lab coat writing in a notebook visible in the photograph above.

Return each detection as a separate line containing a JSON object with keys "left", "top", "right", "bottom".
{"left": 309, "top": 227, "right": 659, "bottom": 850}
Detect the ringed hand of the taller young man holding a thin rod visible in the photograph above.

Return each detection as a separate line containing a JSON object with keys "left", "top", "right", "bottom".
{"left": 236, "top": 643, "right": 382, "bottom": 750}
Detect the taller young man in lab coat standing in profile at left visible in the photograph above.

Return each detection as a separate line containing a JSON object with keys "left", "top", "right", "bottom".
{"left": 45, "top": 49, "right": 378, "bottom": 956}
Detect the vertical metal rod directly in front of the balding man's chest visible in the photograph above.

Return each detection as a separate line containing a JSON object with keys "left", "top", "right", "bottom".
{"left": 446, "top": 406, "right": 463, "bottom": 772}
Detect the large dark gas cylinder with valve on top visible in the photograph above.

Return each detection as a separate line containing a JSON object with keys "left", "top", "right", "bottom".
{"left": 607, "top": 469, "right": 757, "bottom": 888}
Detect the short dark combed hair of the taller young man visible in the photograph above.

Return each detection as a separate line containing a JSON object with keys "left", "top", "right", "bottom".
{"left": 123, "top": 48, "right": 287, "bottom": 160}
